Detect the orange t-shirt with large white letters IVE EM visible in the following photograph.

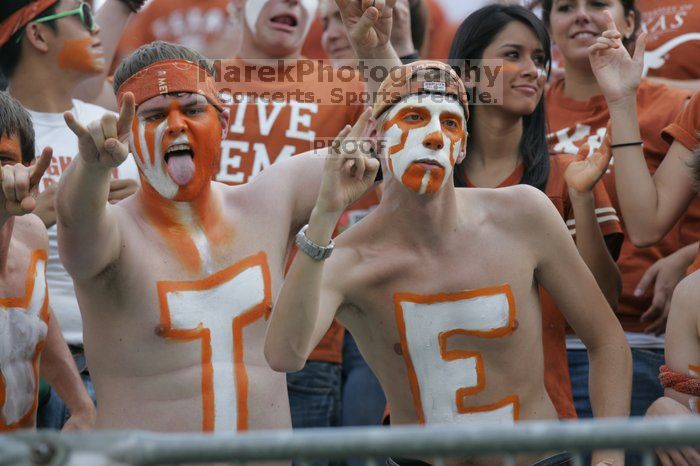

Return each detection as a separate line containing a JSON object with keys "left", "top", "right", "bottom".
{"left": 216, "top": 59, "right": 365, "bottom": 363}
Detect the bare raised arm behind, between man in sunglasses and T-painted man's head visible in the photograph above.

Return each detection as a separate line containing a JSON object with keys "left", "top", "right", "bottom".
{"left": 73, "top": 0, "right": 131, "bottom": 104}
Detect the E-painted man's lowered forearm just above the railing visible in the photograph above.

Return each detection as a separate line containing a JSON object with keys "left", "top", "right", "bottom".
{"left": 588, "top": 334, "right": 632, "bottom": 417}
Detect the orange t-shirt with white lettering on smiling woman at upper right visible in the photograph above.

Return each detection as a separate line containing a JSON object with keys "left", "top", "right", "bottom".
{"left": 545, "top": 79, "right": 700, "bottom": 332}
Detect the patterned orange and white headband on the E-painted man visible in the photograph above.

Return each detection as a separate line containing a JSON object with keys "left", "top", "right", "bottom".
{"left": 372, "top": 60, "right": 469, "bottom": 119}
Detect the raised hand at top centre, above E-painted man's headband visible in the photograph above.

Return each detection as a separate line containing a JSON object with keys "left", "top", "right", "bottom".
{"left": 335, "top": 0, "right": 396, "bottom": 51}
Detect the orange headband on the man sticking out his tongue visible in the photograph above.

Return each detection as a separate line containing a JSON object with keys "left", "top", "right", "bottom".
{"left": 117, "top": 59, "right": 223, "bottom": 111}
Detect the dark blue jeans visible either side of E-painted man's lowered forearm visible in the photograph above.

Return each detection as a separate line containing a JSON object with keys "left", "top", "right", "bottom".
{"left": 567, "top": 348, "right": 664, "bottom": 466}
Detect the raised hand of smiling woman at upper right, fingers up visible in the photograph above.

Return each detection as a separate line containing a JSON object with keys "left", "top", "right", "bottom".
{"left": 588, "top": 11, "right": 647, "bottom": 104}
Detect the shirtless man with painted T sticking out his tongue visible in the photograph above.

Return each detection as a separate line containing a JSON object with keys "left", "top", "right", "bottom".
{"left": 58, "top": 42, "right": 330, "bottom": 431}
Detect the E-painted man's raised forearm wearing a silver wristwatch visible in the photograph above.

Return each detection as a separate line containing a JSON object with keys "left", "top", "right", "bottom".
{"left": 265, "top": 209, "right": 339, "bottom": 372}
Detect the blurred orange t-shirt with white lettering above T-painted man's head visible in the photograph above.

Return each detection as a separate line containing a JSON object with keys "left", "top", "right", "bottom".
{"left": 113, "top": 0, "right": 229, "bottom": 67}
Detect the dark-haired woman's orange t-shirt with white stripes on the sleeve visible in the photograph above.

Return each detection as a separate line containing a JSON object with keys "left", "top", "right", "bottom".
{"left": 467, "top": 154, "right": 622, "bottom": 419}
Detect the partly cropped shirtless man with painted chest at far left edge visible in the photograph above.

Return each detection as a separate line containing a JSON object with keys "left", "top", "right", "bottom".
{"left": 0, "top": 92, "right": 95, "bottom": 433}
